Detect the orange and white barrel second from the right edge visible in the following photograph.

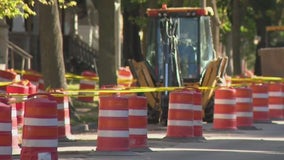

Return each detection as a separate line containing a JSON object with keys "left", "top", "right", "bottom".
{"left": 251, "top": 84, "right": 270, "bottom": 122}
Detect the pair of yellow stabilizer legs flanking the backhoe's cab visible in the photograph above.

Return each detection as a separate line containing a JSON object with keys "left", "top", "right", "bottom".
{"left": 128, "top": 57, "right": 228, "bottom": 122}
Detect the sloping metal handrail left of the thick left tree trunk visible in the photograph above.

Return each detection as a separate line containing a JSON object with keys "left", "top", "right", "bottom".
{"left": 7, "top": 41, "right": 33, "bottom": 70}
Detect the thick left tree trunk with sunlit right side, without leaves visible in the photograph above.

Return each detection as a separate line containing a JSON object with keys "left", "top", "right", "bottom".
{"left": 39, "top": 0, "right": 66, "bottom": 89}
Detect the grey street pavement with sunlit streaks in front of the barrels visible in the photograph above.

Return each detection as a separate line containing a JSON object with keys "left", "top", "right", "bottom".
{"left": 14, "top": 120, "right": 284, "bottom": 160}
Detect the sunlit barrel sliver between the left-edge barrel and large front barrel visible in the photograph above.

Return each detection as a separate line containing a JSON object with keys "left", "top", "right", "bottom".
{"left": 0, "top": 97, "right": 21, "bottom": 154}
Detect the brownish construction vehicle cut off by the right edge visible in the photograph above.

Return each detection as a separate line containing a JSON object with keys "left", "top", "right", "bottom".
{"left": 258, "top": 26, "right": 284, "bottom": 77}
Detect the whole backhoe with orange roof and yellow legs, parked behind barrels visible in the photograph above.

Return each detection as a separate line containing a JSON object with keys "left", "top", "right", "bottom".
{"left": 129, "top": 5, "right": 227, "bottom": 124}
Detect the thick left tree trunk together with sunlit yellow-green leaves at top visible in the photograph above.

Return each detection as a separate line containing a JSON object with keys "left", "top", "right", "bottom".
{"left": 0, "top": 0, "right": 76, "bottom": 88}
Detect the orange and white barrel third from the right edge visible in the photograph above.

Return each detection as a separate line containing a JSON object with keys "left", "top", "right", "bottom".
{"left": 236, "top": 87, "right": 253, "bottom": 128}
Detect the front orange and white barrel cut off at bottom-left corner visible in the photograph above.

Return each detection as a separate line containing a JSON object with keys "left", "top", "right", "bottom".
{"left": 0, "top": 102, "right": 12, "bottom": 160}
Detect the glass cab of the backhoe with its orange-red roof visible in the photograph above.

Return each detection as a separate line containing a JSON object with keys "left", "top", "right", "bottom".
{"left": 146, "top": 6, "right": 215, "bottom": 86}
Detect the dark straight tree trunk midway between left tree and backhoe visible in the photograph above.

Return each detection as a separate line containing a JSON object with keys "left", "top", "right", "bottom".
{"left": 93, "top": 0, "right": 116, "bottom": 86}
